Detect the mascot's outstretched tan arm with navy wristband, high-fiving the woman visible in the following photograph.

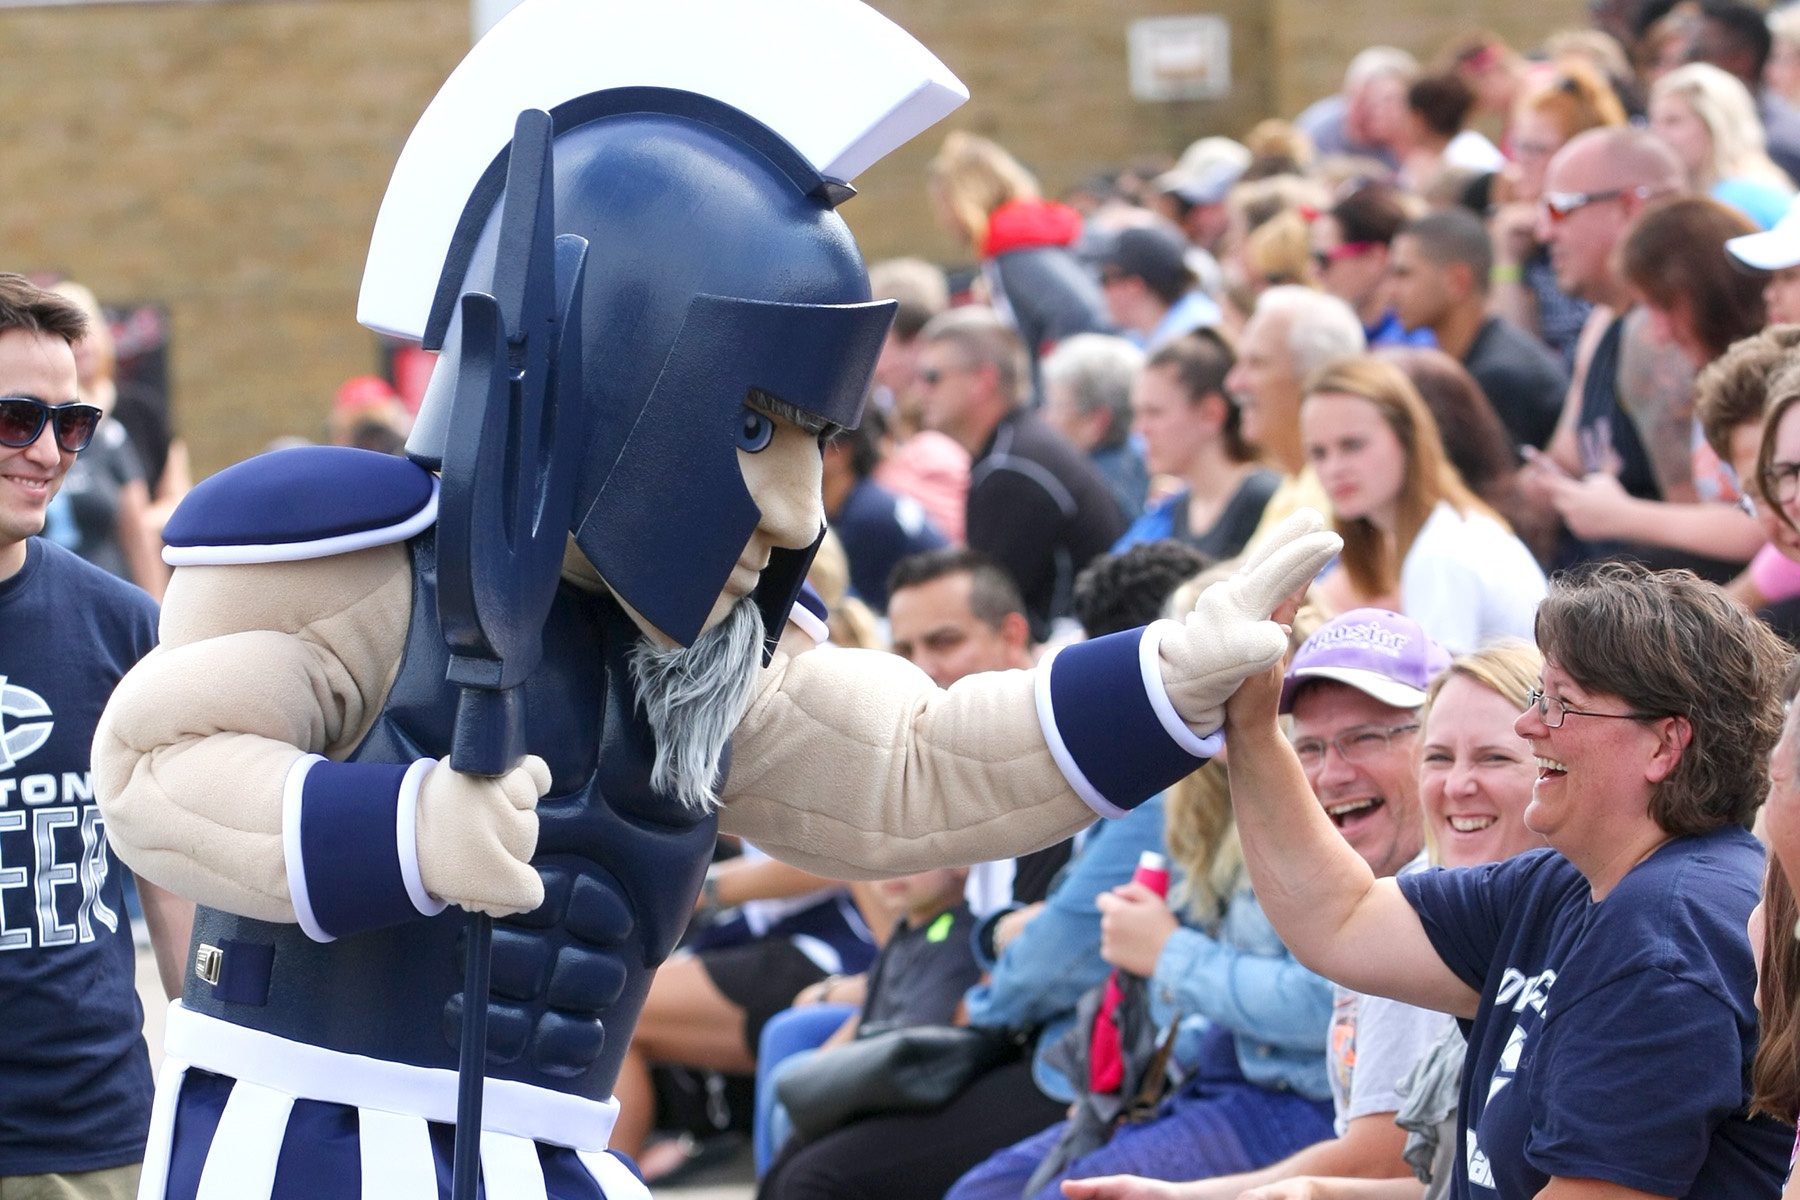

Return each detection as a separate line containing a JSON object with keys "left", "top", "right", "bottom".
{"left": 720, "top": 509, "right": 1341, "bottom": 878}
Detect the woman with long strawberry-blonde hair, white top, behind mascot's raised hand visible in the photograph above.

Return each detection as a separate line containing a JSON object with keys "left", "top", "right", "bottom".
{"left": 1300, "top": 354, "right": 1544, "bottom": 653}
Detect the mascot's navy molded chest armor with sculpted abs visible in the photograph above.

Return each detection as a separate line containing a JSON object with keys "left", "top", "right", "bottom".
{"left": 182, "top": 533, "right": 716, "bottom": 1099}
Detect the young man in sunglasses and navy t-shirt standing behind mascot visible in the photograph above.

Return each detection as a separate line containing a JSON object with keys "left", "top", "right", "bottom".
{"left": 0, "top": 275, "right": 193, "bottom": 1200}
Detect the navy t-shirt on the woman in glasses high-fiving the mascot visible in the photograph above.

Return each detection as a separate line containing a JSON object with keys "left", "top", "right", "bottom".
{"left": 1399, "top": 826, "right": 1795, "bottom": 1200}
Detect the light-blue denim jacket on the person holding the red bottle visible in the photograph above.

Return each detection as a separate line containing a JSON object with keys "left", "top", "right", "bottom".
{"left": 1150, "top": 885, "right": 1332, "bottom": 1099}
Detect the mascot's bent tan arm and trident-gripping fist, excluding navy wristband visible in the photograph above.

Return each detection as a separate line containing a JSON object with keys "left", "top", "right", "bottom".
{"left": 94, "top": 545, "right": 549, "bottom": 921}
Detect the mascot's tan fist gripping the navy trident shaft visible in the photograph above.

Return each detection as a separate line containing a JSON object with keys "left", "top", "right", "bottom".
{"left": 418, "top": 754, "right": 551, "bottom": 918}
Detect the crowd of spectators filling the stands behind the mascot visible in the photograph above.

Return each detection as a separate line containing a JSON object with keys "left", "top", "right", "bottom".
{"left": 65, "top": 0, "right": 1800, "bottom": 1200}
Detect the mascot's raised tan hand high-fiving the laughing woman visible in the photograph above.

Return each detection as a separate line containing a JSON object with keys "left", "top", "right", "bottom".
{"left": 1159, "top": 509, "right": 1343, "bottom": 732}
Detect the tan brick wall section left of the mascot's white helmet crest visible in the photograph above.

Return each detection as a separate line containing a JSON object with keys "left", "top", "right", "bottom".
{"left": 0, "top": 0, "right": 468, "bottom": 473}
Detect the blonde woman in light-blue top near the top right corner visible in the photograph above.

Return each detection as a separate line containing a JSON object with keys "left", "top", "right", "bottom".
{"left": 1651, "top": 63, "right": 1795, "bottom": 228}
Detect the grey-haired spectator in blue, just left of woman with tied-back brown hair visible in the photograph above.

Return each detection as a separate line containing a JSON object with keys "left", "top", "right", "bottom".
{"left": 1044, "top": 333, "right": 1150, "bottom": 522}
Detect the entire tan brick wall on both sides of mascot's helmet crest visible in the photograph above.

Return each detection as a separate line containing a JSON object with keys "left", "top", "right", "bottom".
{"left": 0, "top": 0, "right": 1582, "bottom": 473}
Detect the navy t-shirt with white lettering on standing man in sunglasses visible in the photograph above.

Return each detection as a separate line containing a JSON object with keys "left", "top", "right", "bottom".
{"left": 0, "top": 538, "right": 157, "bottom": 1177}
